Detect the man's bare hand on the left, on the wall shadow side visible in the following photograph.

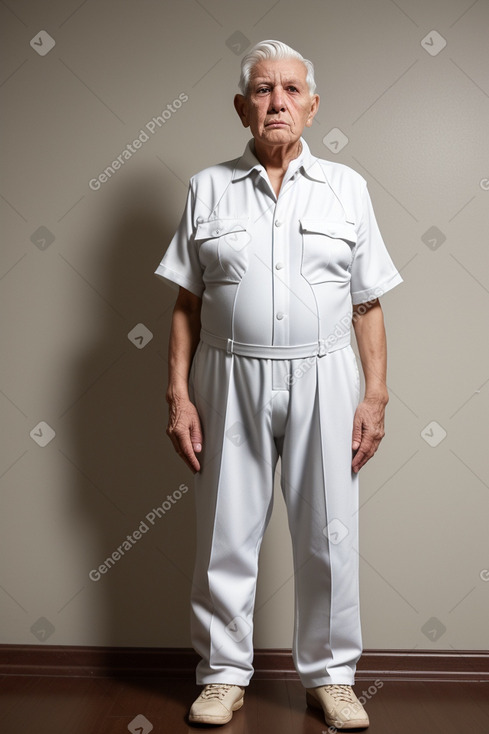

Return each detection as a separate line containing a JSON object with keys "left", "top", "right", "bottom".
{"left": 166, "top": 398, "right": 202, "bottom": 474}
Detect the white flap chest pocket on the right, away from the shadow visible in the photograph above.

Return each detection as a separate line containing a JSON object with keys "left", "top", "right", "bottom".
{"left": 300, "top": 219, "right": 357, "bottom": 284}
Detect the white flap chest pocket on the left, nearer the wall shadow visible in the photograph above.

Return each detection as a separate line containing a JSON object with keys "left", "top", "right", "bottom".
{"left": 195, "top": 217, "right": 251, "bottom": 284}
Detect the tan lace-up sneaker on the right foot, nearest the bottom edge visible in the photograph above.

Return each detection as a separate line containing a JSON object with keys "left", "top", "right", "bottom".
{"left": 306, "top": 685, "right": 370, "bottom": 729}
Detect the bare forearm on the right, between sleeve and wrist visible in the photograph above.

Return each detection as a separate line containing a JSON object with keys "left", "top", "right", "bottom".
{"left": 353, "top": 301, "right": 389, "bottom": 404}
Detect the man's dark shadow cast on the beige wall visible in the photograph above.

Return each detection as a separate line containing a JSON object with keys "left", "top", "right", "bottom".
{"left": 64, "top": 175, "right": 195, "bottom": 663}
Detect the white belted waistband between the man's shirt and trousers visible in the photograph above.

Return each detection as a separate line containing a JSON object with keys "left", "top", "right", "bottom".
{"left": 200, "top": 329, "right": 350, "bottom": 359}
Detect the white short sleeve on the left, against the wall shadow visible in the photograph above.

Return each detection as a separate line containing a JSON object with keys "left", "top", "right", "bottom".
{"left": 155, "top": 182, "right": 204, "bottom": 298}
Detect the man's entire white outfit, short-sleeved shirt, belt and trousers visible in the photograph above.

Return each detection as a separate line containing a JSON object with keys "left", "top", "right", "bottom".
{"left": 156, "top": 138, "right": 402, "bottom": 688}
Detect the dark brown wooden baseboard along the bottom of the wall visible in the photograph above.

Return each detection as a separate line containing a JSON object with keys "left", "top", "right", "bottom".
{"left": 0, "top": 645, "right": 489, "bottom": 682}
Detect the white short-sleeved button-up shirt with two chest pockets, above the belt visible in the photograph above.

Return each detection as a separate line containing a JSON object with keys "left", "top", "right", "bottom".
{"left": 156, "top": 138, "right": 402, "bottom": 354}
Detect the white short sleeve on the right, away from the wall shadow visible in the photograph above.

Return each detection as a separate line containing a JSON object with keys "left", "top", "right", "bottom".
{"left": 350, "top": 184, "right": 403, "bottom": 305}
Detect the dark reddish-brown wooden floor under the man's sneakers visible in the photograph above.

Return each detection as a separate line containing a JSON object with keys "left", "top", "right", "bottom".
{"left": 0, "top": 676, "right": 489, "bottom": 734}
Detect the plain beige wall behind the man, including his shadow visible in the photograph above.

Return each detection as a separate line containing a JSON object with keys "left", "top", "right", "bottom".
{"left": 0, "top": 0, "right": 489, "bottom": 649}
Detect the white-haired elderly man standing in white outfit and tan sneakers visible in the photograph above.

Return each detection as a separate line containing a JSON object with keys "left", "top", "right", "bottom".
{"left": 156, "top": 41, "right": 402, "bottom": 729}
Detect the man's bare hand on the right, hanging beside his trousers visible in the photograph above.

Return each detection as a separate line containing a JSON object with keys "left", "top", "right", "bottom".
{"left": 351, "top": 398, "right": 385, "bottom": 473}
